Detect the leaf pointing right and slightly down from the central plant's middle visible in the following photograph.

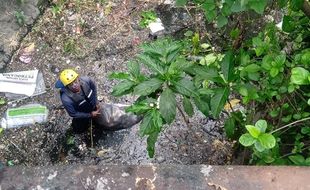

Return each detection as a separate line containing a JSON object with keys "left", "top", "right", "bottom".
{"left": 171, "top": 78, "right": 199, "bottom": 97}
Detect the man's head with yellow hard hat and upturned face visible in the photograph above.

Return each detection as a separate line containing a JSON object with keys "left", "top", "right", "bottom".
{"left": 59, "top": 69, "right": 81, "bottom": 93}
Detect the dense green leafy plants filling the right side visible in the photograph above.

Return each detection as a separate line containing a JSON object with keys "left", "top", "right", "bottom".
{"left": 110, "top": 0, "right": 310, "bottom": 165}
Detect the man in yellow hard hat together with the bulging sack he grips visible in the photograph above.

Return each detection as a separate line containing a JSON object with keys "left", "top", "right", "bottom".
{"left": 55, "top": 69, "right": 141, "bottom": 133}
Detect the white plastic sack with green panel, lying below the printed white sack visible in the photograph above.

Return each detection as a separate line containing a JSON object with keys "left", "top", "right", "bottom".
{"left": 1, "top": 104, "right": 48, "bottom": 129}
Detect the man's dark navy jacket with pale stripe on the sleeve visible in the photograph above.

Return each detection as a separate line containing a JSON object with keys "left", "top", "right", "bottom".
{"left": 60, "top": 77, "right": 98, "bottom": 118}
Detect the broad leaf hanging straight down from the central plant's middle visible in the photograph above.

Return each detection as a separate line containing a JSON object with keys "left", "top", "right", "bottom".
{"left": 159, "top": 88, "right": 177, "bottom": 124}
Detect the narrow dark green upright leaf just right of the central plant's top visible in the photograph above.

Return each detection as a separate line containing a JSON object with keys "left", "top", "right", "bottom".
{"left": 221, "top": 51, "right": 234, "bottom": 82}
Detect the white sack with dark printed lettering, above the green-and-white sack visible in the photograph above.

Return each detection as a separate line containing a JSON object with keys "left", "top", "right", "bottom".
{"left": 0, "top": 70, "right": 45, "bottom": 98}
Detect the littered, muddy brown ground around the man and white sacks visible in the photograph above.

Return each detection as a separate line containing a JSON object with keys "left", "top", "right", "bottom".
{"left": 0, "top": 0, "right": 233, "bottom": 166}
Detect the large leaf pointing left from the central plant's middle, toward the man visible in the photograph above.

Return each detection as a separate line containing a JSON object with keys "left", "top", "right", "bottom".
{"left": 133, "top": 78, "right": 163, "bottom": 96}
